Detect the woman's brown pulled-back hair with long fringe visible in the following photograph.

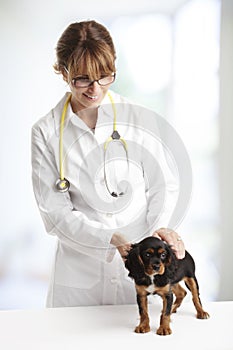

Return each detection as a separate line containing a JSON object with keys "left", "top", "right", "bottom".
{"left": 54, "top": 21, "right": 116, "bottom": 80}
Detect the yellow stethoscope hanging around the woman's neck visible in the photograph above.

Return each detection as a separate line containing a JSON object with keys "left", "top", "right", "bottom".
{"left": 55, "top": 92, "right": 129, "bottom": 197}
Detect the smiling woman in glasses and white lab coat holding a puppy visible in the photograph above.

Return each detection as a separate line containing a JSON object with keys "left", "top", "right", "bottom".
{"left": 32, "top": 21, "right": 184, "bottom": 307}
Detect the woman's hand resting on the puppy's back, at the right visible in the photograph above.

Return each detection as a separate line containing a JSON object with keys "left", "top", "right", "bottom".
{"left": 152, "top": 228, "right": 185, "bottom": 259}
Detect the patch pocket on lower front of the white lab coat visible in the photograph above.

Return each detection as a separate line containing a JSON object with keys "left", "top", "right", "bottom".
{"left": 54, "top": 244, "right": 101, "bottom": 289}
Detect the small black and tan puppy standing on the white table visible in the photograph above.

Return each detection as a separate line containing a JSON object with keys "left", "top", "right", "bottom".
{"left": 125, "top": 237, "right": 209, "bottom": 335}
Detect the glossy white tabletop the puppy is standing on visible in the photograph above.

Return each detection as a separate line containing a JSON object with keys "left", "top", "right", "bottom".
{"left": 0, "top": 301, "right": 233, "bottom": 350}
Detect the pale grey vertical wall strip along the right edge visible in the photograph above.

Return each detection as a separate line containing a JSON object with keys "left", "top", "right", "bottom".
{"left": 219, "top": 0, "right": 233, "bottom": 300}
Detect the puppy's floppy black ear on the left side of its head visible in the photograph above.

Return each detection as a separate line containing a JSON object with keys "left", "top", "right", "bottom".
{"left": 125, "top": 244, "right": 145, "bottom": 284}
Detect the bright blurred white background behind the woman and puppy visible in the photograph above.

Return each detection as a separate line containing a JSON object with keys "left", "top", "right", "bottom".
{"left": 0, "top": 0, "right": 233, "bottom": 309}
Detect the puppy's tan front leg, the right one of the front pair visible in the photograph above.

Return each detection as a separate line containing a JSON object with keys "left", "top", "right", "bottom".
{"left": 156, "top": 291, "right": 173, "bottom": 335}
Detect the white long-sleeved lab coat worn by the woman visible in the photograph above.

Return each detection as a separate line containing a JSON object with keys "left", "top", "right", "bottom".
{"left": 32, "top": 92, "right": 177, "bottom": 307}
